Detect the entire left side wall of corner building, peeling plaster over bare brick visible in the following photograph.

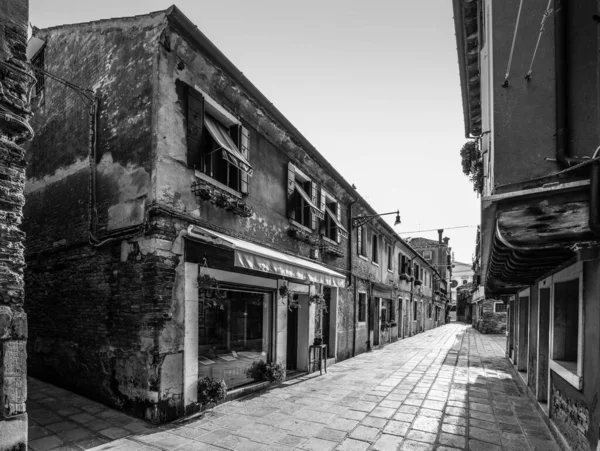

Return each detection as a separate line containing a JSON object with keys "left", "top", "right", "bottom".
{"left": 24, "top": 13, "right": 190, "bottom": 422}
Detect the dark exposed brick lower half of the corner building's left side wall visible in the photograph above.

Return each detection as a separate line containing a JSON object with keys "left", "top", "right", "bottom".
{"left": 26, "top": 231, "right": 180, "bottom": 422}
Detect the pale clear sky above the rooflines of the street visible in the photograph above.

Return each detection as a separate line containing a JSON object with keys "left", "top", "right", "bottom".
{"left": 29, "top": 0, "right": 479, "bottom": 263}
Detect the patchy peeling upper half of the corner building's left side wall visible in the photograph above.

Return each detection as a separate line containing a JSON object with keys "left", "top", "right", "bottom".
{"left": 24, "top": 14, "right": 164, "bottom": 254}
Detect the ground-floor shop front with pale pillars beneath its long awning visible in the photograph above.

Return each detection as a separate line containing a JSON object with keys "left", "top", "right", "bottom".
{"left": 183, "top": 226, "right": 345, "bottom": 414}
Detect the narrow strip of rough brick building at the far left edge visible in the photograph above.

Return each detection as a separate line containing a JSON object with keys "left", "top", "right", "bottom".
{"left": 0, "top": 0, "right": 35, "bottom": 451}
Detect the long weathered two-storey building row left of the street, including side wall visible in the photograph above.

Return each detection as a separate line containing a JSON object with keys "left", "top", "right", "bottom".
{"left": 24, "top": 6, "right": 443, "bottom": 422}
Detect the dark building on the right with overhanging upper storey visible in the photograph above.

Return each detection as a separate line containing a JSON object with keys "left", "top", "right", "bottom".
{"left": 453, "top": 0, "right": 600, "bottom": 450}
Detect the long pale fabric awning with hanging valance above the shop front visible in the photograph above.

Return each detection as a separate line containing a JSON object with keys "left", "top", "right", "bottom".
{"left": 188, "top": 225, "right": 346, "bottom": 287}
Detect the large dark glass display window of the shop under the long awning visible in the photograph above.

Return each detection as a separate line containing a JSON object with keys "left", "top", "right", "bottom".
{"left": 198, "top": 290, "right": 272, "bottom": 388}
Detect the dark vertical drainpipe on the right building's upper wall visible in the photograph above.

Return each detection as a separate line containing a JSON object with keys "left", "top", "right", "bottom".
{"left": 554, "top": 0, "right": 575, "bottom": 169}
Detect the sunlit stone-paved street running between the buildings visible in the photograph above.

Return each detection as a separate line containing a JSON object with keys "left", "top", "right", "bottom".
{"left": 29, "top": 323, "right": 559, "bottom": 451}
